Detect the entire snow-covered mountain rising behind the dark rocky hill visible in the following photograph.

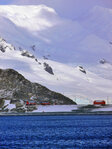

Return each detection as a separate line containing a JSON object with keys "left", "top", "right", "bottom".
{"left": 0, "top": 5, "right": 112, "bottom": 103}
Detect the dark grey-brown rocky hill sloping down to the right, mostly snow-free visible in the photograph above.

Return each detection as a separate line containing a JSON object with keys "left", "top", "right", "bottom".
{"left": 0, "top": 69, "right": 76, "bottom": 105}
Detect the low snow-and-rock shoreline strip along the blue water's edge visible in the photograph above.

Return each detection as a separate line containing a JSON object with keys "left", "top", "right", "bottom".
{"left": 0, "top": 105, "right": 112, "bottom": 116}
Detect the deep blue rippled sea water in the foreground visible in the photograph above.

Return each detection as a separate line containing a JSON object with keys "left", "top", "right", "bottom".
{"left": 0, "top": 115, "right": 112, "bottom": 149}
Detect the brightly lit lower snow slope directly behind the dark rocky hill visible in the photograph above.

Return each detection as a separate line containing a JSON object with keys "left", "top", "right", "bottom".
{"left": 0, "top": 39, "right": 112, "bottom": 103}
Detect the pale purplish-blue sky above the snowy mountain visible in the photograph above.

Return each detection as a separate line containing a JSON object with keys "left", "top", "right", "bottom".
{"left": 0, "top": 0, "right": 112, "bottom": 19}
